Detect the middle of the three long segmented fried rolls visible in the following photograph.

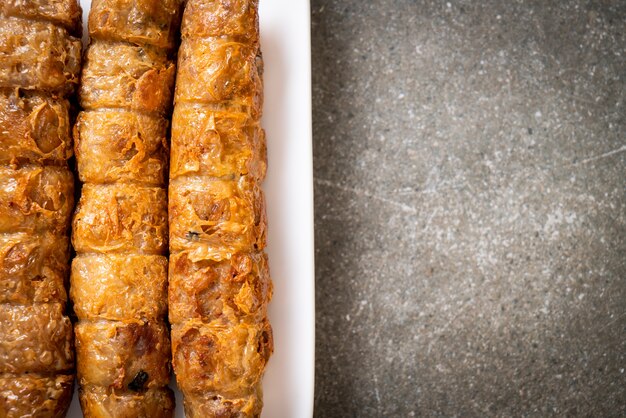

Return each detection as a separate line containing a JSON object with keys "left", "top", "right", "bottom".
{"left": 70, "top": 0, "right": 181, "bottom": 418}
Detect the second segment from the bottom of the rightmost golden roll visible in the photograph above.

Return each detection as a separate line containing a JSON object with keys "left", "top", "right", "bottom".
{"left": 172, "top": 320, "right": 273, "bottom": 398}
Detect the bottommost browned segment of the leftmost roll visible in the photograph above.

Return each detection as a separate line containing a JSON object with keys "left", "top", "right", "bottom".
{"left": 0, "top": 374, "right": 74, "bottom": 418}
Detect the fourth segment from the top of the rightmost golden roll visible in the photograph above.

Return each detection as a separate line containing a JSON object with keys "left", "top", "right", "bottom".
{"left": 169, "top": 177, "right": 267, "bottom": 260}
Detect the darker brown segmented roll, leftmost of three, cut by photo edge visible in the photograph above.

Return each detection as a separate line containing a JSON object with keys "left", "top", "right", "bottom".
{"left": 0, "top": 0, "right": 81, "bottom": 418}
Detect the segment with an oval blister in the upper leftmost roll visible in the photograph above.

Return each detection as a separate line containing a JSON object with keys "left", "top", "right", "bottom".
{"left": 0, "top": 90, "right": 72, "bottom": 165}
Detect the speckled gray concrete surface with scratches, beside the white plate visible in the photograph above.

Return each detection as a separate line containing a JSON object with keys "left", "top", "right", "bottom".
{"left": 311, "top": 0, "right": 626, "bottom": 417}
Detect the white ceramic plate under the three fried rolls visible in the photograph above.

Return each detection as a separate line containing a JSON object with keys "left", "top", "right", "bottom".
{"left": 68, "top": 0, "right": 315, "bottom": 418}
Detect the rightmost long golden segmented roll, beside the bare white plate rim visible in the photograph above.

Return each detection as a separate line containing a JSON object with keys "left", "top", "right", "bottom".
{"left": 168, "top": 0, "right": 273, "bottom": 418}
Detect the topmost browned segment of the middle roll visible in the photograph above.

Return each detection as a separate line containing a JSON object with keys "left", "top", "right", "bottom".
{"left": 89, "top": 0, "right": 182, "bottom": 48}
